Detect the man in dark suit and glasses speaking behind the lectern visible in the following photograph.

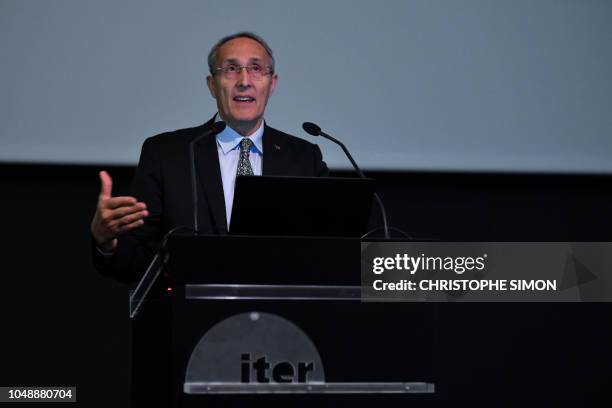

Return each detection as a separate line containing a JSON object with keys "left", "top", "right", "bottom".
{"left": 91, "top": 32, "right": 328, "bottom": 282}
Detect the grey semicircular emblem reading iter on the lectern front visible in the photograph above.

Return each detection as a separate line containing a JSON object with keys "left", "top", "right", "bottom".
{"left": 184, "top": 312, "right": 325, "bottom": 394}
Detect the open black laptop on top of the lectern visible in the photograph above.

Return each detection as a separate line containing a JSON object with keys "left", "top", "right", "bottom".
{"left": 229, "top": 176, "right": 374, "bottom": 237}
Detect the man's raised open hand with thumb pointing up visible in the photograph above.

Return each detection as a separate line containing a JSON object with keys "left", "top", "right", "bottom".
{"left": 91, "top": 171, "right": 149, "bottom": 251}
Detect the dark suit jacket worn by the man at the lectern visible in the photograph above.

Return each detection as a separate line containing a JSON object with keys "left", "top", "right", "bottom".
{"left": 92, "top": 118, "right": 329, "bottom": 282}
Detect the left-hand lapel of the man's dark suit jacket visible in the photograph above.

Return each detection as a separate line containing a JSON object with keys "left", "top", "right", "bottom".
{"left": 195, "top": 118, "right": 227, "bottom": 234}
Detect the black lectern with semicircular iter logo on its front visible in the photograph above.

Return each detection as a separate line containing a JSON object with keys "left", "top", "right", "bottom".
{"left": 130, "top": 234, "right": 434, "bottom": 407}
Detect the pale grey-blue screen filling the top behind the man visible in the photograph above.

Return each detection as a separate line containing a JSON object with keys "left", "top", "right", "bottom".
{"left": 0, "top": 0, "right": 612, "bottom": 173}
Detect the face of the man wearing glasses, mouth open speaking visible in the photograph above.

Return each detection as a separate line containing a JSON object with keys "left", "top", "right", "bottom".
{"left": 207, "top": 37, "right": 277, "bottom": 136}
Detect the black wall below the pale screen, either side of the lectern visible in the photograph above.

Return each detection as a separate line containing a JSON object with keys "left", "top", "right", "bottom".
{"left": 0, "top": 164, "right": 612, "bottom": 407}
